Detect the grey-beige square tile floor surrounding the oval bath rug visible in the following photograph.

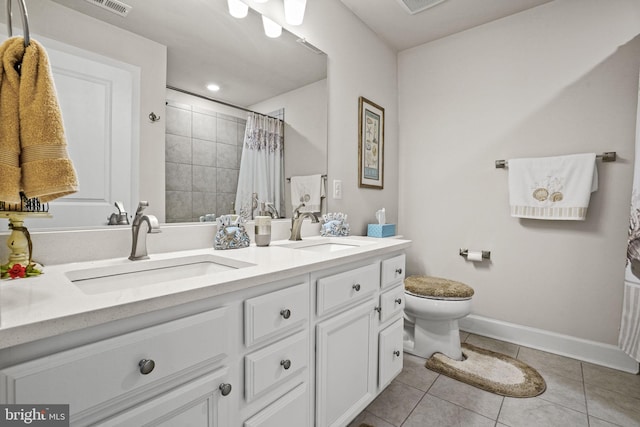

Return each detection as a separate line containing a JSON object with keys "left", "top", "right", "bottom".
{"left": 349, "top": 332, "right": 640, "bottom": 427}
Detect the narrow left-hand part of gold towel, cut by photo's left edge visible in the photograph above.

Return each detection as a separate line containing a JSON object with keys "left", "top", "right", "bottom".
{"left": 0, "top": 37, "right": 24, "bottom": 203}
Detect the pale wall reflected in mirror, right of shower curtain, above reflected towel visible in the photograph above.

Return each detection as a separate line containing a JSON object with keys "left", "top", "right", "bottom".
{"left": 249, "top": 79, "right": 327, "bottom": 218}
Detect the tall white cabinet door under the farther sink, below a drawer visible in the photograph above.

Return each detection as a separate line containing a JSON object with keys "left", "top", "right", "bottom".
{"left": 316, "top": 299, "right": 377, "bottom": 427}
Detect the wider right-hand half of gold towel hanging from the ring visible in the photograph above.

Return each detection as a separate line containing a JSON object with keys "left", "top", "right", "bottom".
{"left": 19, "top": 39, "right": 78, "bottom": 202}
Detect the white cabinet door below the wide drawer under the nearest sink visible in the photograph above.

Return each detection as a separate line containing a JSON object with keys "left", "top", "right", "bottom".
{"left": 98, "top": 368, "right": 230, "bottom": 427}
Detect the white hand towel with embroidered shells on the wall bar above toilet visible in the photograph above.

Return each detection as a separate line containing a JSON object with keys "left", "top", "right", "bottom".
{"left": 509, "top": 153, "right": 598, "bottom": 220}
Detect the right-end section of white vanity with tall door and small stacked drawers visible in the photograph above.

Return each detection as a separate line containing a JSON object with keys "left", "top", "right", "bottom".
{"left": 311, "top": 254, "right": 405, "bottom": 427}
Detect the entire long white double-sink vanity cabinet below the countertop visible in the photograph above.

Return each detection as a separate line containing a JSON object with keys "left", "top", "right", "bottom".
{"left": 0, "top": 244, "right": 404, "bottom": 427}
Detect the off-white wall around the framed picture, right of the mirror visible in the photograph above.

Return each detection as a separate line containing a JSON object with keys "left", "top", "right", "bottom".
{"left": 252, "top": 0, "right": 398, "bottom": 234}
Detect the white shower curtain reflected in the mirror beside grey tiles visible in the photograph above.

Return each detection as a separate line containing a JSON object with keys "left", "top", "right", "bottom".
{"left": 235, "top": 113, "right": 284, "bottom": 219}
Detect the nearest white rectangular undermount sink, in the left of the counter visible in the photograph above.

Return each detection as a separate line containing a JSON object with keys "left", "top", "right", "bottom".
{"left": 65, "top": 254, "right": 253, "bottom": 295}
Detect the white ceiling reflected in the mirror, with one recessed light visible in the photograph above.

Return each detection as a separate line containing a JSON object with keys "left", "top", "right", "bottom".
{"left": 48, "top": 0, "right": 327, "bottom": 107}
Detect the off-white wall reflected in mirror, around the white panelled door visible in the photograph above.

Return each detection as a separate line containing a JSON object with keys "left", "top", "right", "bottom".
{"left": 0, "top": 0, "right": 167, "bottom": 220}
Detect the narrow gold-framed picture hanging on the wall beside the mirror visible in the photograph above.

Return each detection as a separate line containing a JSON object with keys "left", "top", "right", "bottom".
{"left": 358, "top": 96, "right": 384, "bottom": 190}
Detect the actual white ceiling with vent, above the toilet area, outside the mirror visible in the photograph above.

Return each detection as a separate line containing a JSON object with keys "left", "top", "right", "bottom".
{"left": 340, "top": 0, "right": 552, "bottom": 51}
